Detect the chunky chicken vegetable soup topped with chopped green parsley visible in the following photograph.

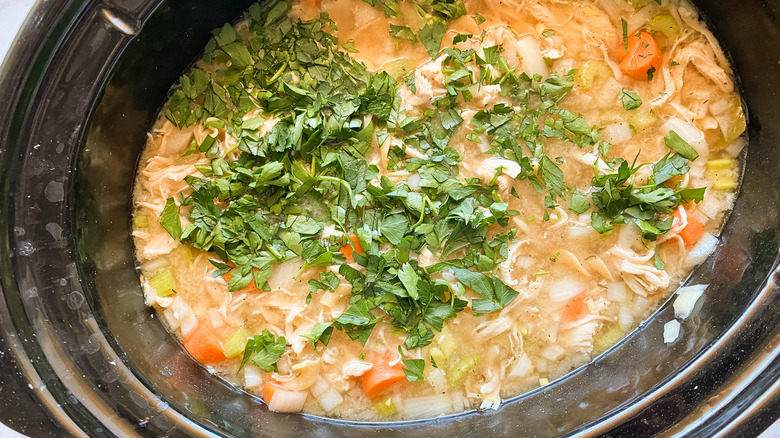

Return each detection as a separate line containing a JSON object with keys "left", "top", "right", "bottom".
{"left": 133, "top": 0, "right": 745, "bottom": 421}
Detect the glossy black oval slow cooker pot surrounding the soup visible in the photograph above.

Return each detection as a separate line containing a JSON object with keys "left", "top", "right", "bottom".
{"left": 0, "top": 0, "right": 780, "bottom": 438}
